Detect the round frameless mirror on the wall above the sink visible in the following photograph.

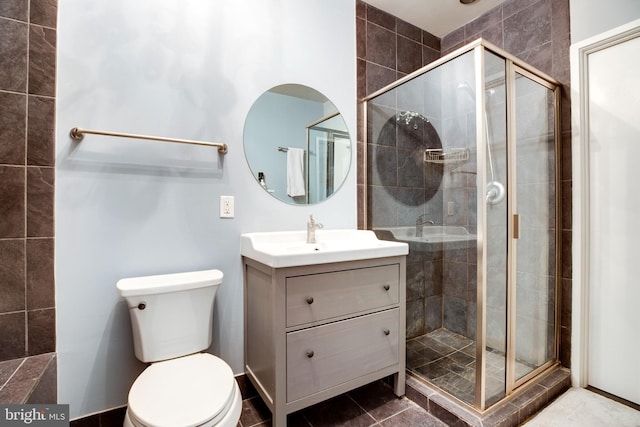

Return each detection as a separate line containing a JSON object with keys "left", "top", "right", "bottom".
{"left": 244, "top": 84, "right": 351, "bottom": 204}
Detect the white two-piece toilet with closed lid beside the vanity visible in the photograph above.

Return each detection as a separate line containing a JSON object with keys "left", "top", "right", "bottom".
{"left": 116, "top": 270, "right": 242, "bottom": 427}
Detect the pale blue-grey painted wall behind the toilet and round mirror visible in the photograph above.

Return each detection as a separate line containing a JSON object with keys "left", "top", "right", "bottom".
{"left": 55, "top": 0, "right": 356, "bottom": 418}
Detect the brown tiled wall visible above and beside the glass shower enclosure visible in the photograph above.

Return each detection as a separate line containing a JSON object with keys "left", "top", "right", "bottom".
{"left": 356, "top": 0, "right": 572, "bottom": 367}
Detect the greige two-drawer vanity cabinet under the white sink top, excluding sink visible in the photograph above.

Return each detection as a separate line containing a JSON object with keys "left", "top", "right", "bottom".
{"left": 243, "top": 256, "right": 406, "bottom": 426}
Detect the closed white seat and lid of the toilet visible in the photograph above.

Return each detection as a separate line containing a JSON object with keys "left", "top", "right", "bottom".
{"left": 128, "top": 353, "right": 239, "bottom": 427}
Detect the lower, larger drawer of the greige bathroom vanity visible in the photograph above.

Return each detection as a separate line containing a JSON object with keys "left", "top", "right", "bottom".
{"left": 287, "top": 308, "right": 399, "bottom": 402}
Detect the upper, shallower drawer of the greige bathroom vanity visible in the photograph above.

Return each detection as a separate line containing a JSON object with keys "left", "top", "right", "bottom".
{"left": 286, "top": 264, "right": 400, "bottom": 327}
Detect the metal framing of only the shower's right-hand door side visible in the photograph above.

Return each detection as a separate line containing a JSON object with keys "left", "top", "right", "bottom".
{"left": 476, "top": 39, "right": 562, "bottom": 412}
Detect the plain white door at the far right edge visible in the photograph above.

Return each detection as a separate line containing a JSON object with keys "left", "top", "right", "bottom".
{"left": 576, "top": 22, "right": 640, "bottom": 404}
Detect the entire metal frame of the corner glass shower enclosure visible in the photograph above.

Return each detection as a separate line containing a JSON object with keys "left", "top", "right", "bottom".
{"left": 362, "top": 38, "right": 562, "bottom": 414}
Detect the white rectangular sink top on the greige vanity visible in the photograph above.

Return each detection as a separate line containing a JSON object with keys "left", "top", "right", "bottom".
{"left": 240, "top": 230, "right": 409, "bottom": 267}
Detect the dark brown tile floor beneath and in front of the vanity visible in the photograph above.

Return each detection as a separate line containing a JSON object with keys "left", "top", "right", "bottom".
{"left": 239, "top": 381, "right": 446, "bottom": 427}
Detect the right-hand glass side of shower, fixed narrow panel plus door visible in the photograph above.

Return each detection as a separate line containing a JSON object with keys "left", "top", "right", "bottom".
{"left": 477, "top": 57, "right": 558, "bottom": 408}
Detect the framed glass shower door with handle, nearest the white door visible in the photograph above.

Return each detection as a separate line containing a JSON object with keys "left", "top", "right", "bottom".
{"left": 507, "top": 67, "right": 557, "bottom": 387}
